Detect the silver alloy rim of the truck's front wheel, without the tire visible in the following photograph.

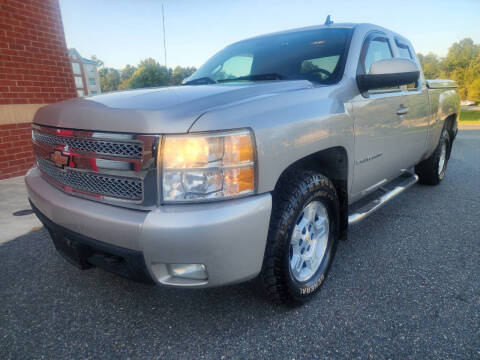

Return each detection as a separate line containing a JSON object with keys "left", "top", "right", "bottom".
{"left": 289, "top": 201, "right": 330, "bottom": 282}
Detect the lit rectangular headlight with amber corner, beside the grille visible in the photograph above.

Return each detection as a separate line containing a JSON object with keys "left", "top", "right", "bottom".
{"left": 162, "top": 130, "right": 255, "bottom": 202}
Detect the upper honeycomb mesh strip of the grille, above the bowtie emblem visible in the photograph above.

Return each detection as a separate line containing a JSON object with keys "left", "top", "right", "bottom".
{"left": 33, "top": 130, "right": 143, "bottom": 159}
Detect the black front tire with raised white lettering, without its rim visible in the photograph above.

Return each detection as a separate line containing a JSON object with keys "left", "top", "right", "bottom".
{"left": 259, "top": 171, "right": 339, "bottom": 305}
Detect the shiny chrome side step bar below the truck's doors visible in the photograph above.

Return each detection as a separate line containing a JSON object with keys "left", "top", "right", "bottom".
{"left": 348, "top": 173, "right": 418, "bottom": 225}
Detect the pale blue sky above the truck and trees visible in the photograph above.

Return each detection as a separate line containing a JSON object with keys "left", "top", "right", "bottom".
{"left": 59, "top": 0, "right": 480, "bottom": 69}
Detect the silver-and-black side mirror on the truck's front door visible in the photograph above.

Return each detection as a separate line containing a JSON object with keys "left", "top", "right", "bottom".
{"left": 357, "top": 59, "right": 420, "bottom": 92}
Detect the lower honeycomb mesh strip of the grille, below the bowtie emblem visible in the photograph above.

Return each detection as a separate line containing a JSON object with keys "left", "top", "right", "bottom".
{"left": 37, "top": 157, "right": 143, "bottom": 201}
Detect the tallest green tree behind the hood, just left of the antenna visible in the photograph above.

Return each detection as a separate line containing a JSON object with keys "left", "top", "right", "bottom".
{"left": 128, "top": 58, "right": 171, "bottom": 89}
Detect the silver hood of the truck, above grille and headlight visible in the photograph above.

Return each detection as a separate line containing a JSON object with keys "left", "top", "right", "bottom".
{"left": 33, "top": 80, "right": 312, "bottom": 134}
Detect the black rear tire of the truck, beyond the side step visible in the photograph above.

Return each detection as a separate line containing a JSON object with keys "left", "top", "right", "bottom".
{"left": 415, "top": 130, "right": 451, "bottom": 185}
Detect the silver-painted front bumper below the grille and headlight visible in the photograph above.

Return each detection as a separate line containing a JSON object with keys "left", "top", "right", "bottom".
{"left": 25, "top": 168, "right": 272, "bottom": 287}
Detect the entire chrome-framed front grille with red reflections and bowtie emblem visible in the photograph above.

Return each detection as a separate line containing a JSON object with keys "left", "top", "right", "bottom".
{"left": 32, "top": 124, "right": 159, "bottom": 209}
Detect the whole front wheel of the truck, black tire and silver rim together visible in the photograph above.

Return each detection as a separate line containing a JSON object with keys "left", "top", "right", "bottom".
{"left": 260, "top": 171, "right": 339, "bottom": 305}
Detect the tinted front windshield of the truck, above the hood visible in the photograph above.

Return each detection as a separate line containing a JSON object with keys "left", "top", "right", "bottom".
{"left": 185, "top": 28, "right": 351, "bottom": 85}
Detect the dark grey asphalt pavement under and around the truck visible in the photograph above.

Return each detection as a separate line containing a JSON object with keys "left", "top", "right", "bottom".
{"left": 0, "top": 130, "right": 480, "bottom": 359}
